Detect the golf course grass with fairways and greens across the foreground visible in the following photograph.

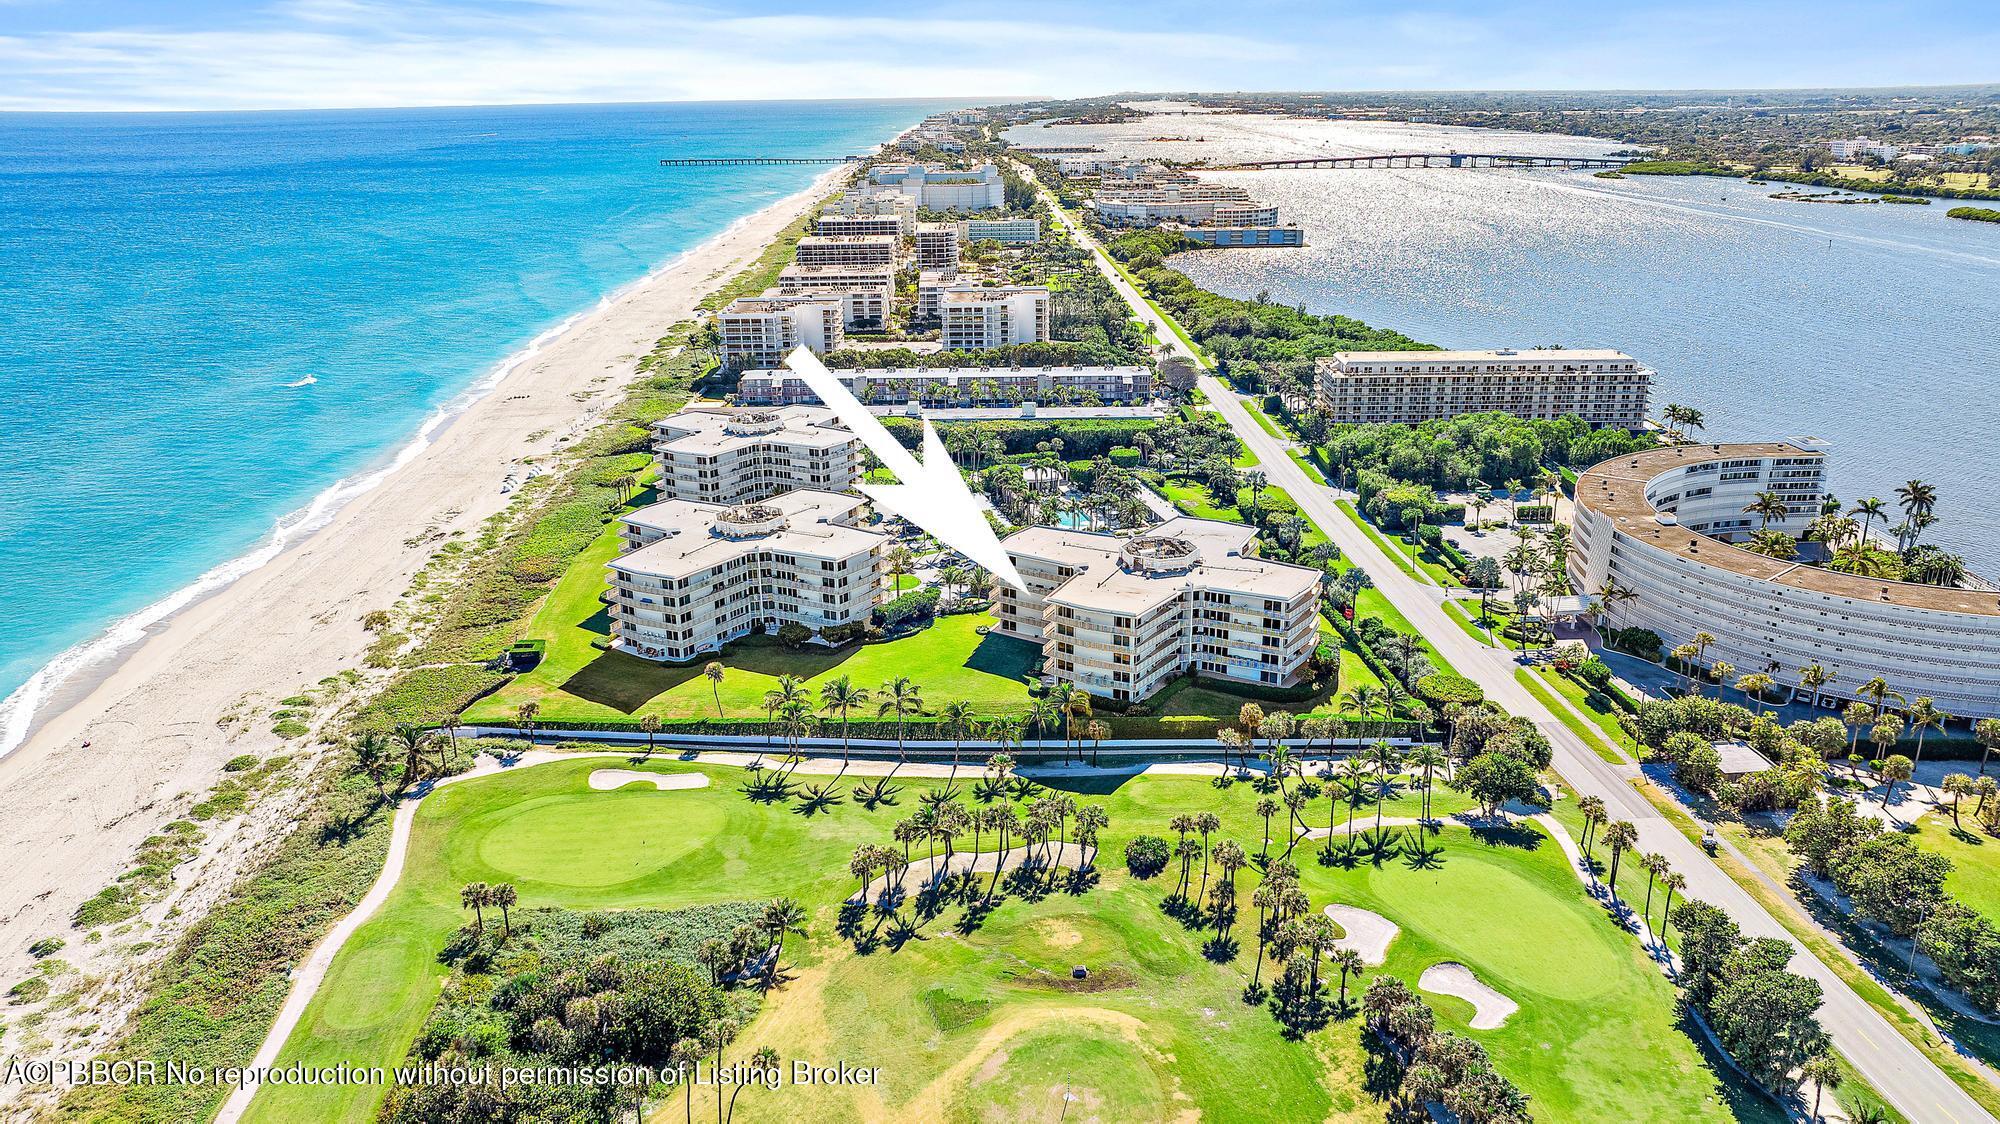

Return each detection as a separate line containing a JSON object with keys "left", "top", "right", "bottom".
{"left": 250, "top": 758, "right": 1768, "bottom": 1122}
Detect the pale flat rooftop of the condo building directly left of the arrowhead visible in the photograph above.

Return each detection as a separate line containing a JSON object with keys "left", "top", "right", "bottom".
{"left": 606, "top": 490, "right": 888, "bottom": 578}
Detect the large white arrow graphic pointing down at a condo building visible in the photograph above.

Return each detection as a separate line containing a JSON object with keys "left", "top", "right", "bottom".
{"left": 784, "top": 348, "right": 1028, "bottom": 592}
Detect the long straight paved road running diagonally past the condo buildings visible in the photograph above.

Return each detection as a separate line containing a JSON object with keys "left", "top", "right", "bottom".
{"left": 1050, "top": 173, "right": 1994, "bottom": 1124}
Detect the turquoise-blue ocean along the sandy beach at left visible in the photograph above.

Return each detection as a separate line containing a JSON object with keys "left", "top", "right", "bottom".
{"left": 0, "top": 102, "right": 944, "bottom": 752}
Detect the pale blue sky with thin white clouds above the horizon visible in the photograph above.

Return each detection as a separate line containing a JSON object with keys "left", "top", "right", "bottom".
{"left": 0, "top": 0, "right": 2000, "bottom": 110}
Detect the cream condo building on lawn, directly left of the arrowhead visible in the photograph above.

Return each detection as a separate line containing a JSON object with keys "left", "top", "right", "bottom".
{"left": 606, "top": 492, "right": 888, "bottom": 662}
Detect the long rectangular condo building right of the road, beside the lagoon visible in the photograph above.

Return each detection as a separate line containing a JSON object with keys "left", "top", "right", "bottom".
{"left": 1318, "top": 348, "right": 1652, "bottom": 430}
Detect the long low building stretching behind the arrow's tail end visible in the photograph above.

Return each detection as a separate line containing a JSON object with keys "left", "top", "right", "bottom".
{"left": 736, "top": 364, "right": 1152, "bottom": 406}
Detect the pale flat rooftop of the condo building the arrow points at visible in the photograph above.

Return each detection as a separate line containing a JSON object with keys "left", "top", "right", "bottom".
{"left": 1004, "top": 516, "right": 1320, "bottom": 614}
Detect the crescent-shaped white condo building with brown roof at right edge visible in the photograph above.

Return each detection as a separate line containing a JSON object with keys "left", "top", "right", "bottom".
{"left": 1568, "top": 440, "right": 2000, "bottom": 718}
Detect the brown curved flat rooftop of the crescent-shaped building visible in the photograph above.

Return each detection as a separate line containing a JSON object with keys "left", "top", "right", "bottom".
{"left": 1576, "top": 442, "right": 2000, "bottom": 616}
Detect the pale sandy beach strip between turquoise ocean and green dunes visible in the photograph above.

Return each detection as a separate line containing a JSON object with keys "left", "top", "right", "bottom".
{"left": 0, "top": 168, "right": 848, "bottom": 1034}
